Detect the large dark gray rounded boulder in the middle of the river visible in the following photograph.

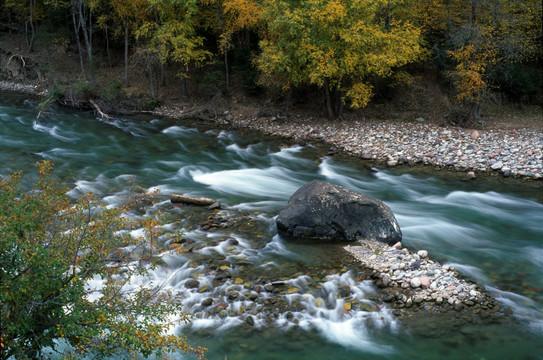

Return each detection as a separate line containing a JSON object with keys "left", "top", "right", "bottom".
{"left": 276, "top": 180, "right": 402, "bottom": 244}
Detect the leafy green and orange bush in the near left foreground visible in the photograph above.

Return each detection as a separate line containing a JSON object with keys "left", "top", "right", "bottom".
{"left": 0, "top": 162, "right": 204, "bottom": 359}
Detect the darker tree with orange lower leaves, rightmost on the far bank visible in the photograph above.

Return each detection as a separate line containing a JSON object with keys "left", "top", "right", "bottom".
{"left": 411, "top": 0, "right": 542, "bottom": 122}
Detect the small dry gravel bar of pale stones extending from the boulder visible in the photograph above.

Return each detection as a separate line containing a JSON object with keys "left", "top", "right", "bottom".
{"left": 344, "top": 241, "right": 501, "bottom": 318}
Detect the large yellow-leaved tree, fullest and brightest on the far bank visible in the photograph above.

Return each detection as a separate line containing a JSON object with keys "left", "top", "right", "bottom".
{"left": 257, "top": 0, "right": 422, "bottom": 118}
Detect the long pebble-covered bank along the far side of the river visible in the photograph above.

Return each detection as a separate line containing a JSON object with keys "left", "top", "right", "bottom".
{"left": 207, "top": 114, "right": 543, "bottom": 180}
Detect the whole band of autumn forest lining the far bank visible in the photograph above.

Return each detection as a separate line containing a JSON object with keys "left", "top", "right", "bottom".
{"left": 0, "top": 0, "right": 542, "bottom": 121}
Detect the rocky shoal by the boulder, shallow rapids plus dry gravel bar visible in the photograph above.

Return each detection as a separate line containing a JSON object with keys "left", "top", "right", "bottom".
{"left": 167, "top": 200, "right": 507, "bottom": 328}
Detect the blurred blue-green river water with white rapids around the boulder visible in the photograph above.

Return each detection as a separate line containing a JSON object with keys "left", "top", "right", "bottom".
{"left": 0, "top": 95, "right": 543, "bottom": 360}
